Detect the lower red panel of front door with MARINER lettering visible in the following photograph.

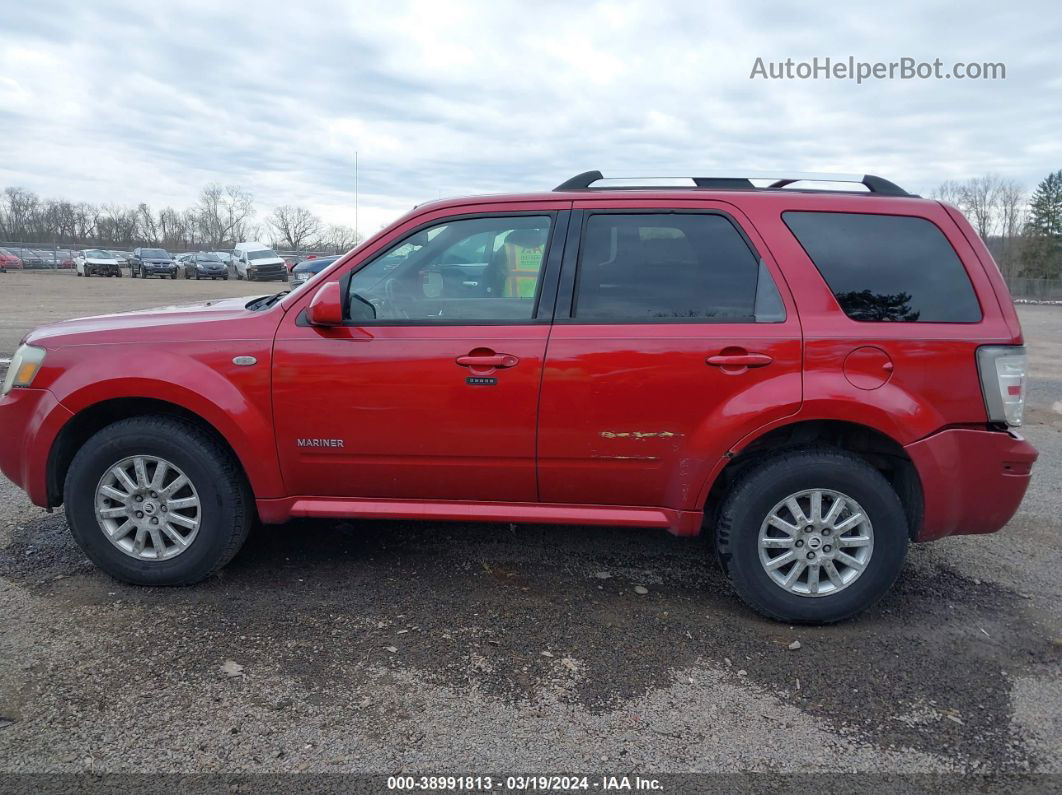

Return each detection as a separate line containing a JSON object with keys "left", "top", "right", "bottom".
{"left": 273, "top": 313, "right": 549, "bottom": 502}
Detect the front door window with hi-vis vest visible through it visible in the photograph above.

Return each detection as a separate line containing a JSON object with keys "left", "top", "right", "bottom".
{"left": 348, "top": 215, "right": 550, "bottom": 324}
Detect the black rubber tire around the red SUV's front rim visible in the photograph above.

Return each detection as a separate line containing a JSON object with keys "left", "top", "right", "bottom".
{"left": 64, "top": 416, "right": 254, "bottom": 585}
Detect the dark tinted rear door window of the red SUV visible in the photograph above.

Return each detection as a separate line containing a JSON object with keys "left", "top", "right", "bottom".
{"left": 575, "top": 213, "right": 785, "bottom": 323}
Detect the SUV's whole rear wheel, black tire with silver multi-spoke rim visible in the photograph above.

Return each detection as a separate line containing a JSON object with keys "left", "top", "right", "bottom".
{"left": 716, "top": 449, "right": 908, "bottom": 624}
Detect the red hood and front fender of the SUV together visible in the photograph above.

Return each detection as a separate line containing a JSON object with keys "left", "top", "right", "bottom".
{"left": 16, "top": 299, "right": 285, "bottom": 498}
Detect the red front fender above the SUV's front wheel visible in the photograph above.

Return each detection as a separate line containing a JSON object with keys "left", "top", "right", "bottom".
{"left": 41, "top": 340, "right": 285, "bottom": 498}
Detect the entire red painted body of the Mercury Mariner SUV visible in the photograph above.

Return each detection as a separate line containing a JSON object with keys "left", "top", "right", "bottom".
{"left": 0, "top": 190, "right": 1035, "bottom": 539}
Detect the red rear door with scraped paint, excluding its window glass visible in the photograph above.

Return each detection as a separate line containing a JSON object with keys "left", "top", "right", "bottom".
{"left": 538, "top": 197, "right": 801, "bottom": 511}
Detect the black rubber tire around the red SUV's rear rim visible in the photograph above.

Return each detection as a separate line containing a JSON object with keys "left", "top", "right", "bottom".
{"left": 716, "top": 448, "right": 908, "bottom": 624}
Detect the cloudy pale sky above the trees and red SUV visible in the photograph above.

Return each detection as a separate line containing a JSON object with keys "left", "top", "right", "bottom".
{"left": 0, "top": 0, "right": 1062, "bottom": 235}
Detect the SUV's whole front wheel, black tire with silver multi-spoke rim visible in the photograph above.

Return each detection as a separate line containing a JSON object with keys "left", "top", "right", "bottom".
{"left": 64, "top": 417, "right": 253, "bottom": 585}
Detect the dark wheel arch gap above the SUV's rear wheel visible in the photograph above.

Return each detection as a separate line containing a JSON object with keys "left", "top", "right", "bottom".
{"left": 702, "top": 419, "right": 924, "bottom": 540}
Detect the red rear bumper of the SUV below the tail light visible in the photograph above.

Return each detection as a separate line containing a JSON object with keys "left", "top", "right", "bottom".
{"left": 905, "top": 428, "right": 1039, "bottom": 541}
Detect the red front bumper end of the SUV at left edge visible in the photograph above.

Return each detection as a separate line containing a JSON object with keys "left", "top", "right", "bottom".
{"left": 0, "top": 390, "right": 73, "bottom": 507}
